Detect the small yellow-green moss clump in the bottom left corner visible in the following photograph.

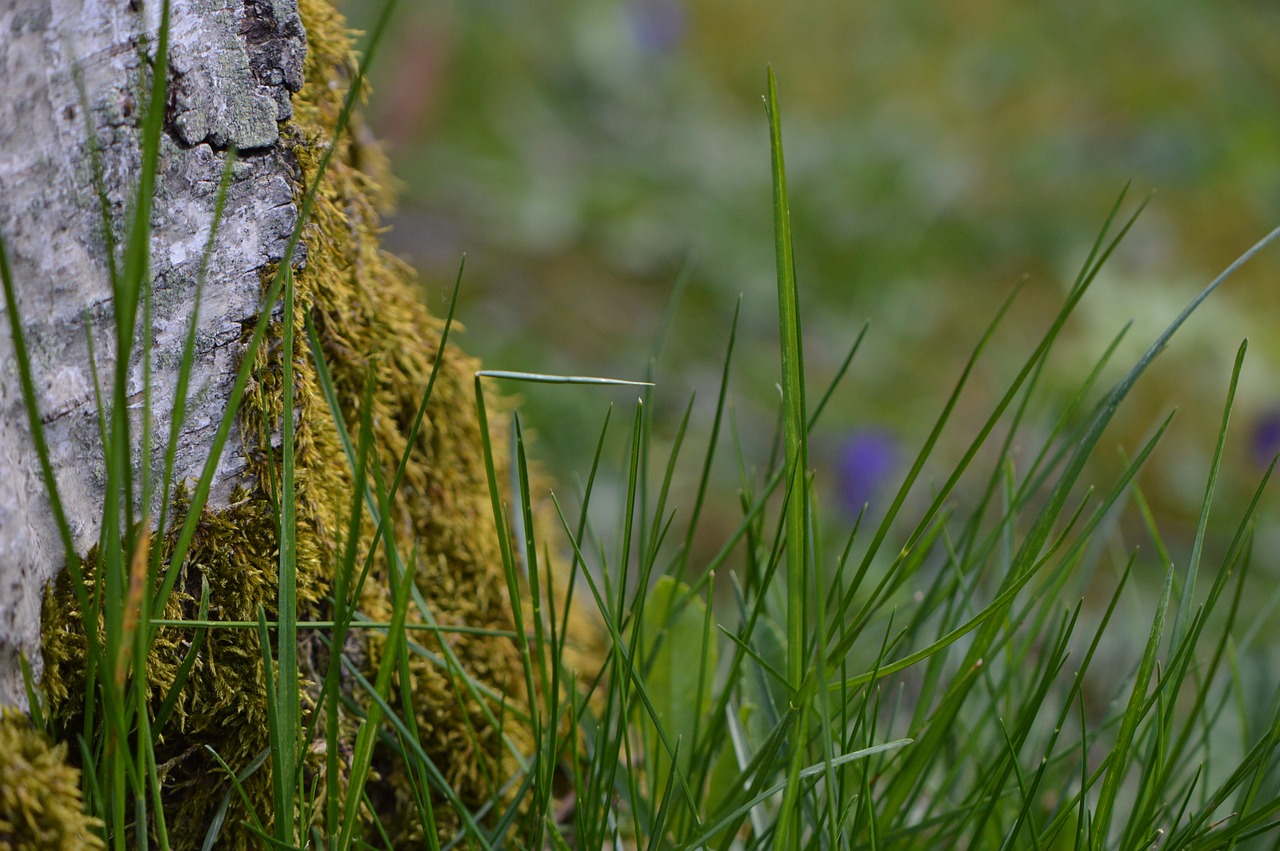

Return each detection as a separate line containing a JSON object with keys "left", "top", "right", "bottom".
{"left": 0, "top": 709, "right": 102, "bottom": 851}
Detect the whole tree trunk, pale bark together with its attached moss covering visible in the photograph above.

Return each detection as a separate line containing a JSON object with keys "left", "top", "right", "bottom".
{"left": 0, "top": 0, "right": 588, "bottom": 847}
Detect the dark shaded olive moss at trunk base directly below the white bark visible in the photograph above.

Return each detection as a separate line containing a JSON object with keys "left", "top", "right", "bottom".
{"left": 41, "top": 491, "right": 294, "bottom": 848}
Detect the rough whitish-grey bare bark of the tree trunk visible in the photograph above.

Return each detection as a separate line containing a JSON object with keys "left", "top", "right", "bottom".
{"left": 0, "top": 0, "right": 306, "bottom": 705}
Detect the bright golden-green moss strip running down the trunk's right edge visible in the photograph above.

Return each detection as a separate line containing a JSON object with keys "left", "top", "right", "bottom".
{"left": 292, "top": 0, "right": 540, "bottom": 843}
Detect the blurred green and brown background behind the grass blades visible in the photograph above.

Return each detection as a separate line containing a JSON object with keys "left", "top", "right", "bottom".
{"left": 346, "top": 0, "right": 1280, "bottom": 570}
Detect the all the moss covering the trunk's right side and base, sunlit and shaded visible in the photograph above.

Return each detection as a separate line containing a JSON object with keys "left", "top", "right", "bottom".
{"left": 36, "top": 0, "right": 604, "bottom": 848}
